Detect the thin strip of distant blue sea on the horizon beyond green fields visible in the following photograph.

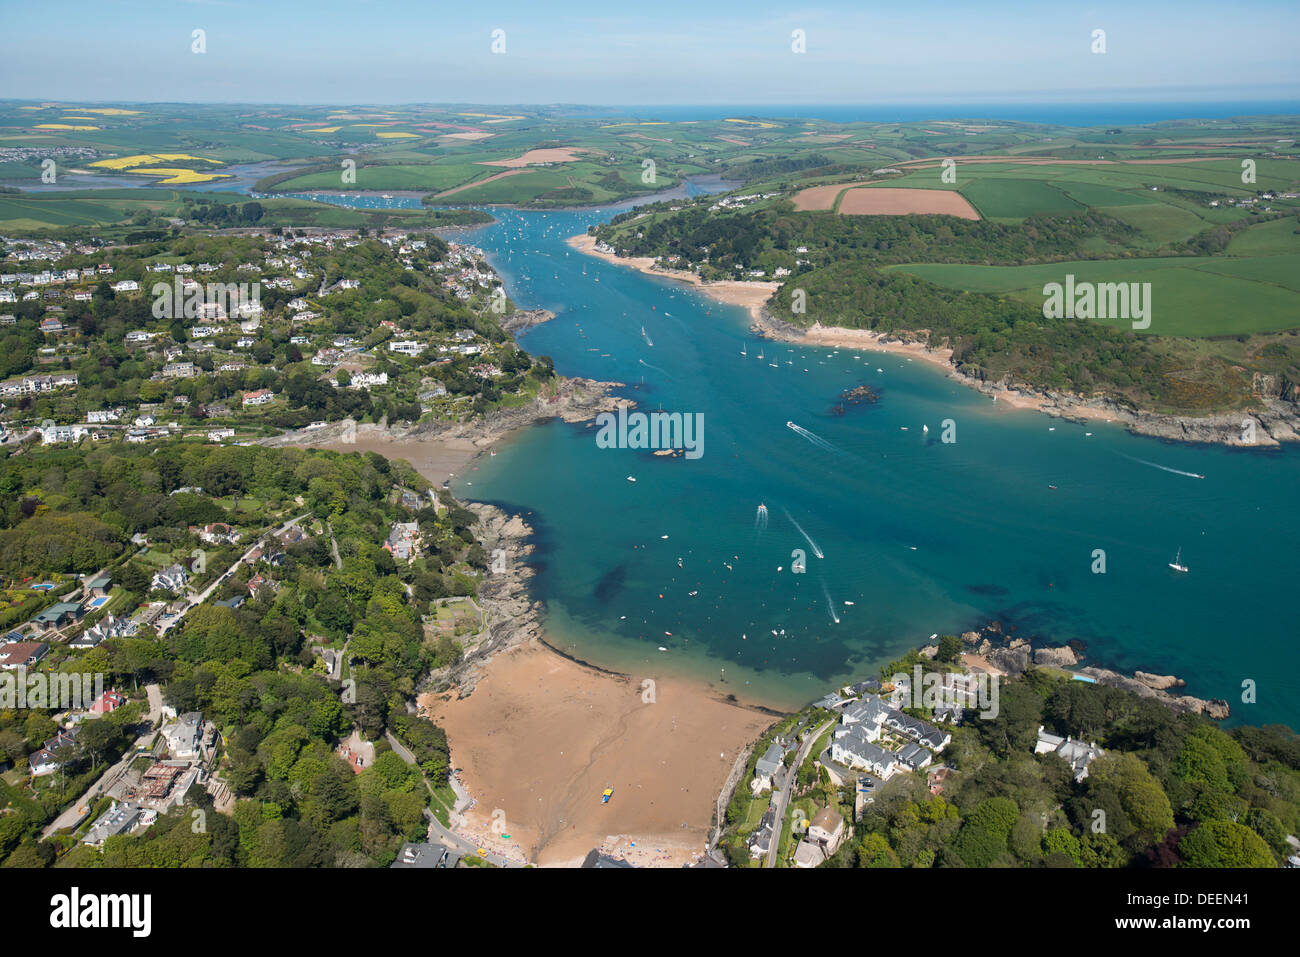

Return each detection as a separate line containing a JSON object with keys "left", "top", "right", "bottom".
{"left": 566, "top": 99, "right": 1300, "bottom": 126}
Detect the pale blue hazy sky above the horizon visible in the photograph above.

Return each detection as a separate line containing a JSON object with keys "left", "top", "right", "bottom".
{"left": 0, "top": 0, "right": 1300, "bottom": 104}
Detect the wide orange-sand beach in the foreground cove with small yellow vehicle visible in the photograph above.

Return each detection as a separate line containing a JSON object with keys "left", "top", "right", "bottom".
{"left": 420, "top": 641, "right": 772, "bottom": 867}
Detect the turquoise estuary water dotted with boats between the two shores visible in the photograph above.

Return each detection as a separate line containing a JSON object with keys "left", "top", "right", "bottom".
{"left": 439, "top": 209, "right": 1300, "bottom": 727}
